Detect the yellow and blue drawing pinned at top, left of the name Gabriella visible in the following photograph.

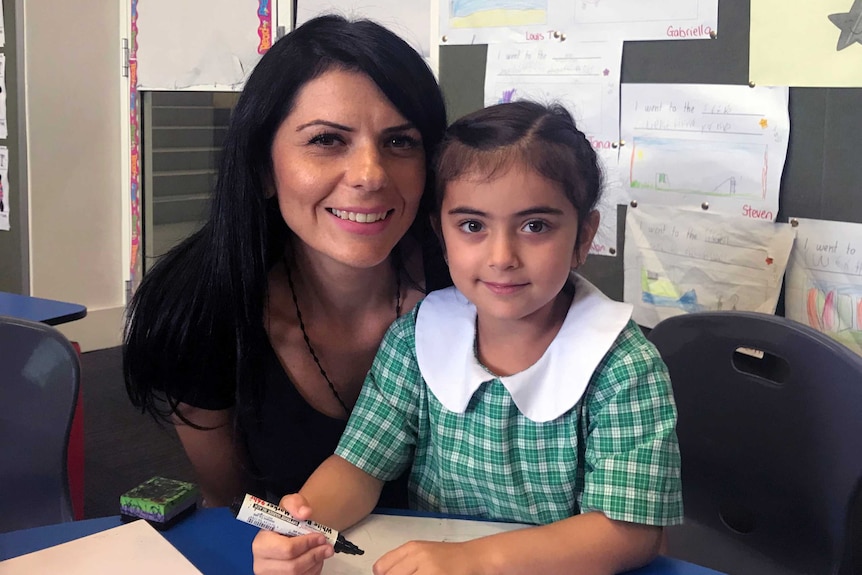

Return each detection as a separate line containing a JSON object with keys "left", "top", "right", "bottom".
{"left": 449, "top": 0, "right": 548, "bottom": 28}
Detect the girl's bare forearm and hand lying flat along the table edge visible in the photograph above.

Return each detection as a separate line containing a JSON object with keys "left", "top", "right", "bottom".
{"left": 374, "top": 512, "right": 662, "bottom": 575}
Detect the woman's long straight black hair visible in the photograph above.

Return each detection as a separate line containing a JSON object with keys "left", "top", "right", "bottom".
{"left": 123, "top": 16, "right": 446, "bottom": 426}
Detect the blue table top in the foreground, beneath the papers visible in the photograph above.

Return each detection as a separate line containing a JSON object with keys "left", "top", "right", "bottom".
{"left": 0, "top": 508, "right": 722, "bottom": 575}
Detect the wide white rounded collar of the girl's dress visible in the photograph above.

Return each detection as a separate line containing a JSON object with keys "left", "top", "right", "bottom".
{"left": 416, "top": 274, "right": 632, "bottom": 422}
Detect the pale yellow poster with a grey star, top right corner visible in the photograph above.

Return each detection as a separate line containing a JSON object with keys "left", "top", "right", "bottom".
{"left": 748, "top": 0, "right": 862, "bottom": 88}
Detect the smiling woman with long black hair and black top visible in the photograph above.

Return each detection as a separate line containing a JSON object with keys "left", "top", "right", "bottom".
{"left": 123, "top": 16, "right": 450, "bottom": 506}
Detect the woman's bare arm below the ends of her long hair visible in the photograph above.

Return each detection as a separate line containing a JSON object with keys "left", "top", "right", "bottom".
{"left": 171, "top": 403, "right": 250, "bottom": 507}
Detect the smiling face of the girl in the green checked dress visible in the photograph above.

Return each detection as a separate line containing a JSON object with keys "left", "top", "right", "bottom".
{"left": 440, "top": 165, "right": 598, "bottom": 328}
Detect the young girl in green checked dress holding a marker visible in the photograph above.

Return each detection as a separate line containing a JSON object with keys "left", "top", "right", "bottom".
{"left": 254, "top": 102, "right": 682, "bottom": 575}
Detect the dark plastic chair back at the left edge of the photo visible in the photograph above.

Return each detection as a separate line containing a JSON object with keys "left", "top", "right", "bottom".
{"left": 0, "top": 316, "right": 81, "bottom": 532}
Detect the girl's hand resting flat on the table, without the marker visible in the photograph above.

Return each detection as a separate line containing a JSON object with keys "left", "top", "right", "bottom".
{"left": 374, "top": 541, "right": 482, "bottom": 575}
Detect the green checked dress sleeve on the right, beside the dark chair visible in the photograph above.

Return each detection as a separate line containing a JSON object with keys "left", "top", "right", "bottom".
{"left": 580, "top": 322, "right": 683, "bottom": 525}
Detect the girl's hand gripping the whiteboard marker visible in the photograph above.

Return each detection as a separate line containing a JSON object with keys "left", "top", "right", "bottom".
{"left": 251, "top": 493, "right": 335, "bottom": 575}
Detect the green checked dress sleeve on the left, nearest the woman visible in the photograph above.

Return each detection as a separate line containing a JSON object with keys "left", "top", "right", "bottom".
{"left": 335, "top": 305, "right": 422, "bottom": 481}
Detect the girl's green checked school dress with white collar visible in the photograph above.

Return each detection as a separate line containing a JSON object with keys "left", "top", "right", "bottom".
{"left": 336, "top": 275, "right": 682, "bottom": 525}
